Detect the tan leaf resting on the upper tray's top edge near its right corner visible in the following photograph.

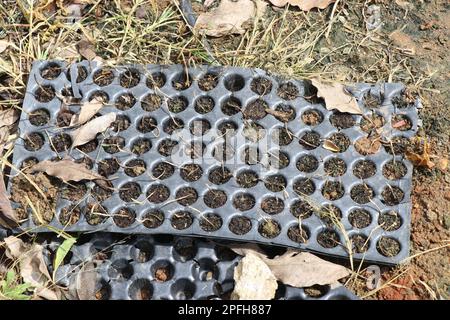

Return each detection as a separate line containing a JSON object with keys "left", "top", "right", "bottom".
{"left": 311, "top": 79, "right": 362, "bottom": 114}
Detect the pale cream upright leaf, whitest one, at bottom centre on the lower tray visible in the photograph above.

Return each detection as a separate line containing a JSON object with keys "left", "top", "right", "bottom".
{"left": 231, "top": 253, "right": 278, "bottom": 300}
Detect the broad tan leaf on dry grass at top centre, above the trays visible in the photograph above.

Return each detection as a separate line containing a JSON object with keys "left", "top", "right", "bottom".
{"left": 194, "top": 0, "right": 267, "bottom": 37}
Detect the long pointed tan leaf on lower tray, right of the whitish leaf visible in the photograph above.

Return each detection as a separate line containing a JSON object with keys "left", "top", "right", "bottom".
{"left": 230, "top": 245, "right": 350, "bottom": 288}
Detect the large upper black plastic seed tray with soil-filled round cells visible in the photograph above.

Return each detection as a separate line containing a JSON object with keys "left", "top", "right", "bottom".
{"left": 13, "top": 61, "right": 419, "bottom": 264}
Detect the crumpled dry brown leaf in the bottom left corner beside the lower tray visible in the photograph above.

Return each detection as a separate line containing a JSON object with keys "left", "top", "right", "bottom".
{"left": 4, "top": 236, "right": 60, "bottom": 300}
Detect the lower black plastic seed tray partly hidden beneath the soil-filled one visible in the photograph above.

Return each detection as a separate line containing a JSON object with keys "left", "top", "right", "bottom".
{"left": 46, "top": 233, "right": 358, "bottom": 300}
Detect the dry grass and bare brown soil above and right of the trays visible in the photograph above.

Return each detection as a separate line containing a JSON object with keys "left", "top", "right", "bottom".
{"left": 0, "top": 0, "right": 450, "bottom": 299}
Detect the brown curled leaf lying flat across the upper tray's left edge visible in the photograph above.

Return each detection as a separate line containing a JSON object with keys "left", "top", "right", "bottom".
{"left": 30, "top": 159, "right": 104, "bottom": 182}
